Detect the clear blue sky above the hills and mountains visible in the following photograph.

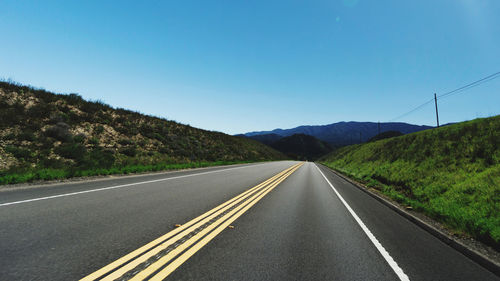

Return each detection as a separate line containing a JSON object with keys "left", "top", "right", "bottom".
{"left": 0, "top": 0, "right": 500, "bottom": 134}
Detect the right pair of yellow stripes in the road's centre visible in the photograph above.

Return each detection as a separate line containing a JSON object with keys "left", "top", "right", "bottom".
{"left": 130, "top": 165, "right": 301, "bottom": 281}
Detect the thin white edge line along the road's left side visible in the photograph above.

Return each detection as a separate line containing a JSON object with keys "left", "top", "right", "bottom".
{"left": 0, "top": 163, "right": 266, "bottom": 207}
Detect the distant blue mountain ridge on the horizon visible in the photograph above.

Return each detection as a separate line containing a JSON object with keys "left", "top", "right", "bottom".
{"left": 244, "top": 121, "right": 433, "bottom": 146}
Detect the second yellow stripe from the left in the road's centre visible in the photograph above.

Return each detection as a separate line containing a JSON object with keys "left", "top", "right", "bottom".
{"left": 102, "top": 165, "right": 297, "bottom": 281}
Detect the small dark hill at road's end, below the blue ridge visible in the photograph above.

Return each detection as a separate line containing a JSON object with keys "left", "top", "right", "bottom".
{"left": 270, "top": 134, "right": 332, "bottom": 161}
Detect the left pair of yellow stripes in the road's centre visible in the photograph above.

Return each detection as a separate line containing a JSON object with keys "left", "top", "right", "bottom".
{"left": 81, "top": 163, "right": 301, "bottom": 281}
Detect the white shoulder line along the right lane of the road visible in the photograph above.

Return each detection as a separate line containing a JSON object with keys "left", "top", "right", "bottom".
{"left": 314, "top": 164, "right": 410, "bottom": 281}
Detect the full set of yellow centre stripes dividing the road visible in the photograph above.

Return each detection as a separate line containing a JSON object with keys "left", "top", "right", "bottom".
{"left": 81, "top": 163, "right": 303, "bottom": 281}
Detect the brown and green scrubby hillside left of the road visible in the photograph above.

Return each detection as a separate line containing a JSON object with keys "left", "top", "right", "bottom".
{"left": 0, "top": 82, "right": 284, "bottom": 183}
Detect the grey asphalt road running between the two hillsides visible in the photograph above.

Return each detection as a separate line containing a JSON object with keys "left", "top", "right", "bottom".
{"left": 0, "top": 161, "right": 500, "bottom": 280}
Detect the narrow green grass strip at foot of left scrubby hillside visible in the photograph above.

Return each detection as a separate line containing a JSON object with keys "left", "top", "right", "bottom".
{"left": 0, "top": 161, "right": 251, "bottom": 185}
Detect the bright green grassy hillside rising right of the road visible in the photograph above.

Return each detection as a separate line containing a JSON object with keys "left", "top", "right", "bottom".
{"left": 322, "top": 116, "right": 500, "bottom": 250}
